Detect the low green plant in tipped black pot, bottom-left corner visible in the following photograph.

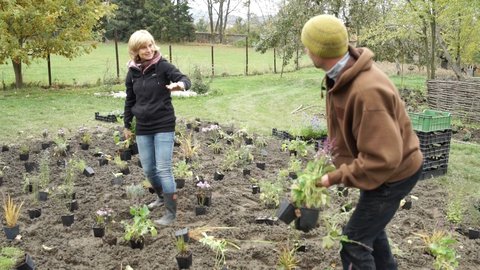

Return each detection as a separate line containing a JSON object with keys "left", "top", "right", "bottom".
{"left": 0, "top": 247, "right": 35, "bottom": 270}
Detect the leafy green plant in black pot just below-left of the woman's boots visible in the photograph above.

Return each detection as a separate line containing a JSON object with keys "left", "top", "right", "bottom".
{"left": 122, "top": 205, "right": 157, "bottom": 249}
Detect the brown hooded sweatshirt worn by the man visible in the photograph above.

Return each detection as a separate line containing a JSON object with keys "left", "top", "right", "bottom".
{"left": 325, "top": 47, "right": 423, "bottom": 190}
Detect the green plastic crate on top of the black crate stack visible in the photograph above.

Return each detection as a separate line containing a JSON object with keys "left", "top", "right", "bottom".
{"left": 408, "top": 110, "right": 451, "bottom": 132}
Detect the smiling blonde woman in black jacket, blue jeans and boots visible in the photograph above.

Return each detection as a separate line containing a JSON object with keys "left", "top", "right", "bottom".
{"left": 124, "top": 30, "right": 191, "bottom": 225}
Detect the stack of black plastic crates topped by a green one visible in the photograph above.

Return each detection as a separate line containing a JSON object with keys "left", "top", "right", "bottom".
{"left": 409, "top": 110, "right": 452, "bottom": 179}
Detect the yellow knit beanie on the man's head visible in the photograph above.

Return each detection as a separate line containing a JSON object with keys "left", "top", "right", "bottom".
{"left": 302, "top": 14, "right": 348, "bottom": 58}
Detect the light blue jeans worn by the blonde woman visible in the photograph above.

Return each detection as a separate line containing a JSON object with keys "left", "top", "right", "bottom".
{"left": 137, "top": 132, "right": 176, "bottom": 193}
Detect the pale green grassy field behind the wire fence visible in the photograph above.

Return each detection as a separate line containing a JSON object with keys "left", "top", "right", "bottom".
{"left": 0, "top": 42, "right": 310, "bottom": 86}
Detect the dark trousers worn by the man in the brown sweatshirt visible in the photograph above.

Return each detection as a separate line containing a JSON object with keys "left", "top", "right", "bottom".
{"left": 340, "top": 167, "right": 422, "bottom": 270}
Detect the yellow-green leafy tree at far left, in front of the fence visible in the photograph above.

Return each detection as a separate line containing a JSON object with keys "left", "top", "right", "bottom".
{"left": 0, "top": 0, "right": 115, "bottom": 88}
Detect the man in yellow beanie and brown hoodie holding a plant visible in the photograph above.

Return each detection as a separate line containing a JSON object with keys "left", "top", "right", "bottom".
{"left": 301, "top": 15, "right": 423, "bottom": 270}
